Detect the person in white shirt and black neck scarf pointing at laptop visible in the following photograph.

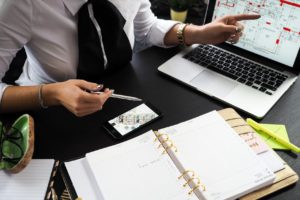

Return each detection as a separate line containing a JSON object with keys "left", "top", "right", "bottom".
{"left": 0, "top": 0, "right": 260, "bottom": 117}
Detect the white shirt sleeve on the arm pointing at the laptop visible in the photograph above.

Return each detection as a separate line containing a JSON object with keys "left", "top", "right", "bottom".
{"left": 134, "top": 0, "right": 179, "bottom": 51}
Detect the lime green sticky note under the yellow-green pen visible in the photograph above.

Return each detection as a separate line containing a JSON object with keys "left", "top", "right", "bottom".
{"left": 256, "top": 124, "right": 290, "bottom": 150}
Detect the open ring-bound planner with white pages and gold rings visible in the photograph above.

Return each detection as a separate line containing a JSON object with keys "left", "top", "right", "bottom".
{"left": 62, "top": 109, "right": 298, "bottom": 200}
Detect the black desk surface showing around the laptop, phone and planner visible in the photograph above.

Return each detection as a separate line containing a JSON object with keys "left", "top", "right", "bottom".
{"left": 2, "top": 47, "right": 300, "bottom": 200}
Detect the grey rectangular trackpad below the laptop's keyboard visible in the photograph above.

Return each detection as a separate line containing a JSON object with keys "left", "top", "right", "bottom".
{"left": 190, "top": 70, "right": 238, "bottom": 98}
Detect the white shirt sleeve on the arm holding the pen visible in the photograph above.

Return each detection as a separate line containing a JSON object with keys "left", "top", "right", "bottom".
{"left": 0, "top": 0, "right": 32, "bottom": 101}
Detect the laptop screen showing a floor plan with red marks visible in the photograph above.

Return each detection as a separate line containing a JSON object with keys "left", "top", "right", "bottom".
{"left": 212, "top": 0, "right": 300, "bottom": 67}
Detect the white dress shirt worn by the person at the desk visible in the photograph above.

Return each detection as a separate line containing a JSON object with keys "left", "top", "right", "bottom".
{"left": 0, "top": 0, "right": 177, "bottom": 100}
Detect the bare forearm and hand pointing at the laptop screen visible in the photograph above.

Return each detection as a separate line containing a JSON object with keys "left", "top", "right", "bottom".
{"left": 164, "top": 14, "right": 260, "bottom": 45}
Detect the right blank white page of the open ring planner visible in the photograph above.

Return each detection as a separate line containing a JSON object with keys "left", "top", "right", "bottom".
{"left": 159, "top": 111, "right": 275, "bottom": 199}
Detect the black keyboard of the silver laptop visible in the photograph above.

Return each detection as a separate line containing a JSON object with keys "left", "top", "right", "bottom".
{"left": 183, "top": 45, "right": 288, "bottom": 95}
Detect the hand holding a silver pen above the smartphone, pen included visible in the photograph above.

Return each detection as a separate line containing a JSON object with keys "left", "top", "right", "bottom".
{"left": 54, "top": 79, "right": 139, "bottom": 117}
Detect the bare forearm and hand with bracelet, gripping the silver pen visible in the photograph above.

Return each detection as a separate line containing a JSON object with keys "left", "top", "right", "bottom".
{"left": 0, "top": 80, "right": 112, "bottom": 117}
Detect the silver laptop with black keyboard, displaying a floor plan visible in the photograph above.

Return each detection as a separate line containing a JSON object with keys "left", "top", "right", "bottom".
{"left": 158, "top": 0, "right": 300, "bottom": 118}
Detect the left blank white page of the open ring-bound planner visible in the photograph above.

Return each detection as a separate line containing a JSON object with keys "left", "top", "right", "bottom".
{"left": 83, "top": 131, "right": 197, "bottom": 200}
